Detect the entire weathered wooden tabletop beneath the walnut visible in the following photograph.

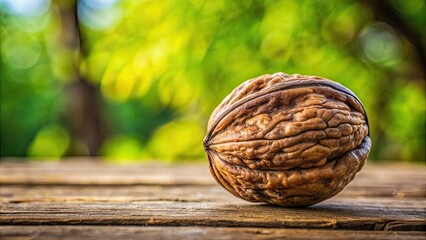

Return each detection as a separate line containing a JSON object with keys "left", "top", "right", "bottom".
{"left": 0, "top": 159, "right": 426, "bottom": 240}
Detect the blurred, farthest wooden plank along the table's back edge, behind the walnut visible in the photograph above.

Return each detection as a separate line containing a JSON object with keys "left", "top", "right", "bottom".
{"left": 0, "top": 160, "right": 426, "bottom": 188}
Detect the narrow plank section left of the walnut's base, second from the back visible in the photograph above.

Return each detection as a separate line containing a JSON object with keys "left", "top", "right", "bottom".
{"left": 0, "top": 185, "right": 236, "bottom": 203}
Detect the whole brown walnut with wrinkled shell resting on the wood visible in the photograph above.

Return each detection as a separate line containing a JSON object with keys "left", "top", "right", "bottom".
{"left": 204, "top": 73, "right": 371, "bottom": 207}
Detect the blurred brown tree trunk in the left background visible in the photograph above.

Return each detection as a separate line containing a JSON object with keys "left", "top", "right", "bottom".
{"left": 58, "top": 0, "right": 106, "bottom": 156}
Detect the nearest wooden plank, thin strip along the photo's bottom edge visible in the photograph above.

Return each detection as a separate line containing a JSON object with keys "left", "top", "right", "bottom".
{"left": 0, "top": 226, "right": 426, "bottom": 240}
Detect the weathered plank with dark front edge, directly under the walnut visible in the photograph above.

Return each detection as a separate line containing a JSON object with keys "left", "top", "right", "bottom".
{"left": 0, "top": 198, "right": 426, "bottom": 230}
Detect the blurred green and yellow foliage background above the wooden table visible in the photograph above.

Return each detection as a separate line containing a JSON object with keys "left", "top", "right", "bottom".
{"left": 0, "top": 0, "right": 426, "bottom": 162}
